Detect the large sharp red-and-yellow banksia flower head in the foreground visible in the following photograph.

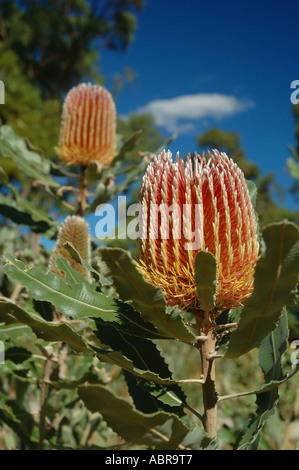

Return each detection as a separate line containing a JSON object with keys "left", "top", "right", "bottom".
{"left": 138, "top": 150, "right": 259, "bottom": 312}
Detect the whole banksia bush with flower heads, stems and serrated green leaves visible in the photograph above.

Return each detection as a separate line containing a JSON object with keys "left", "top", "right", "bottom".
{"left": 0, "top": 84, "right": 299, "bottom": 452}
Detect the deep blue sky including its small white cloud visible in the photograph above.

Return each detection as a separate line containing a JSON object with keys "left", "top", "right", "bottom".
{"left": 100, "top": 0, "right": 299, "bottom": 209}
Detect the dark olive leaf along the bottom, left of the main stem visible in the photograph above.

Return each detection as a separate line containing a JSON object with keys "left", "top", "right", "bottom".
{"left": 78, "top": 386, "right": 215, "bottom": 450}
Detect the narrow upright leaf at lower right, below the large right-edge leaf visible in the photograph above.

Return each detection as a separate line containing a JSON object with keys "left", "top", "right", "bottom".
{"left": 238, "top": 312, "right": 289, "bottom": 450}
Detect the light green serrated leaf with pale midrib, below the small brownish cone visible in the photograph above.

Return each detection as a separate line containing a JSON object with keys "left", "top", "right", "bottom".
{"left": 3, "top": 256, "right": 119, "bottom": 321}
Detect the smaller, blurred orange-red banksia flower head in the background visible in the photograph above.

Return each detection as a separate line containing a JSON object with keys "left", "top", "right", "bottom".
{"left": 56, "top": 83, "right": 116, "bottom": 166}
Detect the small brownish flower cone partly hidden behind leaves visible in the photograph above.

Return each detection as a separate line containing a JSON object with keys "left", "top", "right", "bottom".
{"left": 48, "top": 215, "right": 91, "bottom": 282}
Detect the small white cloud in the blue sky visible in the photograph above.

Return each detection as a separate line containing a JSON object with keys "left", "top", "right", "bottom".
{"left": 137, "top": 93, "right": 254, "bottom": 133}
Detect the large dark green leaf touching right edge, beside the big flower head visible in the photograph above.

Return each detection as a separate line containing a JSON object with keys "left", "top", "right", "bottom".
{"left": 225, "top": 221, "right": 299, "bottom": 358}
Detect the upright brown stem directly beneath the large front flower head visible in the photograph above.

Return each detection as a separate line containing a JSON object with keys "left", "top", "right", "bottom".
{"left": 196, "top": 312, "right": 218, "bottom": 438}
